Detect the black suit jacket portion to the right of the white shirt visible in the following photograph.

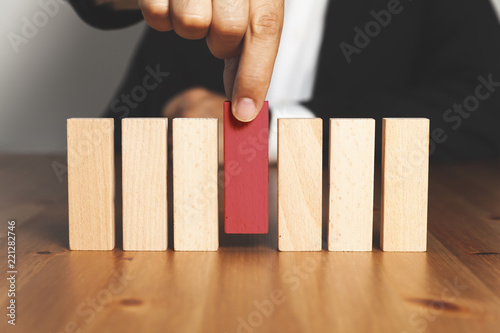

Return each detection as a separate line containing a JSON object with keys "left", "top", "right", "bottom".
{"left": 305, "top": 0, "right": 500, "bottom": 160}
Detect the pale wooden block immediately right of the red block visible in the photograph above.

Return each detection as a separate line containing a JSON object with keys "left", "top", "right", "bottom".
{"left": 278, "top": 118, "right": 323, "bottom": 251}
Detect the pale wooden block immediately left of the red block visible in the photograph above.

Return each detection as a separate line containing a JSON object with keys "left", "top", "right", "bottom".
{"left": 172, "top": 118, "right": 219, "bottom": 251}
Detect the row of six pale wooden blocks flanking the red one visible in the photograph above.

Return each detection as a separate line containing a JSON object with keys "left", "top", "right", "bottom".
{"left": 67, "top": 115, "right": 429, "bottom": 251}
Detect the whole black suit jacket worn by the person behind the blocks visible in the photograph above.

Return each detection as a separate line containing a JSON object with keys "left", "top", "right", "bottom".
{"left": 71, "top": 0, "right": 500, "bottom": 160}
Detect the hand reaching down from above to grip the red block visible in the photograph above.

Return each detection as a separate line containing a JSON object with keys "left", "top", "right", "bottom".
{"left": 138, "top": 0, "right": 284, "bottom": 121}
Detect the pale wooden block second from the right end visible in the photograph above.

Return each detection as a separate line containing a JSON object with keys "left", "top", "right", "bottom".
{"left": 328, "top": 119, "right": 375, "bottom": 251}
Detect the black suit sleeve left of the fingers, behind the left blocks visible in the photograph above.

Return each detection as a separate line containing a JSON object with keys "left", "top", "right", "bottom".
{"left": 103, "top": 28, "right": 224, "bottom": 149}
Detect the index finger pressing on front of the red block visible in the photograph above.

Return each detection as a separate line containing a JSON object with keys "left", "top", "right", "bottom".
{"left": 232, "top": 0, "right": 284, "bottom": 122}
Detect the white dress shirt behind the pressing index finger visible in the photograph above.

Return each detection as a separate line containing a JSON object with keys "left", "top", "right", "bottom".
{"left": 266, "top": 0, "right": 328, "bottom": 163}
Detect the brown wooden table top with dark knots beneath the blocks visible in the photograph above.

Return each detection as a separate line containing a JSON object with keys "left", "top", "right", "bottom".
{"left": 0, "top": 155, "right": 500, "bottom": 333}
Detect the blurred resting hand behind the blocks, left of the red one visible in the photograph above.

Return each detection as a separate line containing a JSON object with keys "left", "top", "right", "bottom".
{"left": 162, "top": 88, "right": 226, "bottom": 164}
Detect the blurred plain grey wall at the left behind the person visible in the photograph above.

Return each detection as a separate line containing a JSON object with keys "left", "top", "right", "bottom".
{"left": 0, "top": 0, "right": 500, "bottom": 153}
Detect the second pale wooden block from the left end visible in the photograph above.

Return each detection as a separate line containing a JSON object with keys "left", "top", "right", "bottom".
{"left": 122, "top": 118, "right": 168, "bottom": 251}
